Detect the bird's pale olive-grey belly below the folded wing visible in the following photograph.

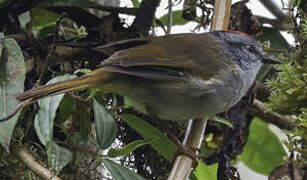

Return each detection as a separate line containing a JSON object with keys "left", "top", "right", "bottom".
{"left": 120, "top": 73, "right": 242, "bottom": 121}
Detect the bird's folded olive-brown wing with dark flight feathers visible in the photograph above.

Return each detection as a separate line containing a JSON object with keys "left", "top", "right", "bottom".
{"left": 100, "top": 36, "right": 184, "bottom": 80}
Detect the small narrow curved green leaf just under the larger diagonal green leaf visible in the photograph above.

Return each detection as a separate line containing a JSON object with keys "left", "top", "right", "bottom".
{"left": 108, "top": 140, "right": 151, "bottom": 157}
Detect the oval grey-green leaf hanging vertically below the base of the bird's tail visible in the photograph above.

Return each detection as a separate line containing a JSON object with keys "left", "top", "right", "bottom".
{"left": 93, "top": 99, "right": 117, "bottom": 149}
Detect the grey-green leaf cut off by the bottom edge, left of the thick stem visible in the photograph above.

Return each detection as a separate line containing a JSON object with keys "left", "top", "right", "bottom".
{"left": 102, "top": 159, "right": 145, "bottom": 180}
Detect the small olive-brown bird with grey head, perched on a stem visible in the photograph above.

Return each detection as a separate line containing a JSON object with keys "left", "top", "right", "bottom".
{"left": 17, "top": 31, "right": 279, "bottom": 121}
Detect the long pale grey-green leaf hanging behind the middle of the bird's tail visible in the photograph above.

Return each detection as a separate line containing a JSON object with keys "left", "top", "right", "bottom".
{"left": 34, "top": 75, "right": 76, "bottom": 145}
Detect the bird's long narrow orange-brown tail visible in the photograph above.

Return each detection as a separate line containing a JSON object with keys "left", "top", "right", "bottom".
{"left": 16, "top": 70, "right": 109, "bottom": 101}
